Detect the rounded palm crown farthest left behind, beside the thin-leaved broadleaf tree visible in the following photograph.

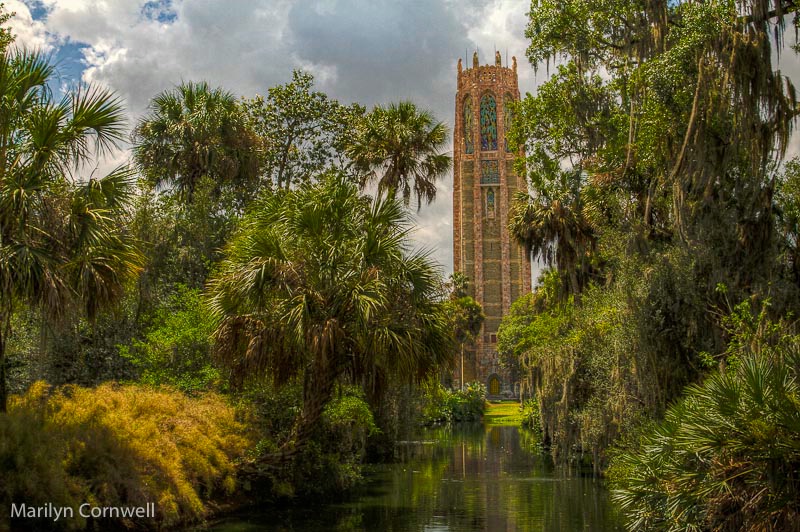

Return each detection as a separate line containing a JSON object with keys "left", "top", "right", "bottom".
{"left": 133, "top": 82, "right": 258, "bottom": 203}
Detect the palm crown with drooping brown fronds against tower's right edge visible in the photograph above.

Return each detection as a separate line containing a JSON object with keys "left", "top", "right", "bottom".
{"left": 509, "top": 172, "right": 597, "bottom": 294}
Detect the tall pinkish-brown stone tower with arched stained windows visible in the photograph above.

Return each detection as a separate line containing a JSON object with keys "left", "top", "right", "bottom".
{"left": 453, "top": 52, "right": 531, "bottom": 396}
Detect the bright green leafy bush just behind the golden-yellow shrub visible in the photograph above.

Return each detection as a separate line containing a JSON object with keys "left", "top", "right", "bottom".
{"left": 119, "top": 285, "right": 219, "bottom": 392}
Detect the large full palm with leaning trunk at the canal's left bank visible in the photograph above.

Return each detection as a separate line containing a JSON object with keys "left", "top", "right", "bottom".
{"left": 209, "top": 174, "right": 452, "bottom": 461}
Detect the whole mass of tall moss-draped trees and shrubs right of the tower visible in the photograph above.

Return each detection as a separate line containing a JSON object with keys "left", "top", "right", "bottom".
{"left": 498, "top": 0, "right": 800, "bottom": 482}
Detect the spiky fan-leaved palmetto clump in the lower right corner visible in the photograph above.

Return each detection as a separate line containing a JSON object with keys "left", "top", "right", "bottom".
{"left": 609, "top": 306, "right": 800, "bottom": 530}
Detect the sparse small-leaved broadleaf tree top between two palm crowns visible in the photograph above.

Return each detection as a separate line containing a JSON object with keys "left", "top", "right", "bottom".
{"left": 243, "top": 70, "right": 365, "bottom": 189}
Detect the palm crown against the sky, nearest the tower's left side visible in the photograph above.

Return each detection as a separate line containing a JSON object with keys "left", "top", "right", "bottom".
{"left": 348, "top": 102, "right": 451, "bottom": 209}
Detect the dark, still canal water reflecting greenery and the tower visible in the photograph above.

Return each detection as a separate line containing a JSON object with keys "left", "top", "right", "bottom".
{"left": 206, "top": 425, "right": 622, "bottom": 532}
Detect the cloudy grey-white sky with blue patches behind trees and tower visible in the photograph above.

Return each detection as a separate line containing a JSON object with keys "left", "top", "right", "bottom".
{"left": 2, "top": 0, "right": 800, "bottom": 273}
